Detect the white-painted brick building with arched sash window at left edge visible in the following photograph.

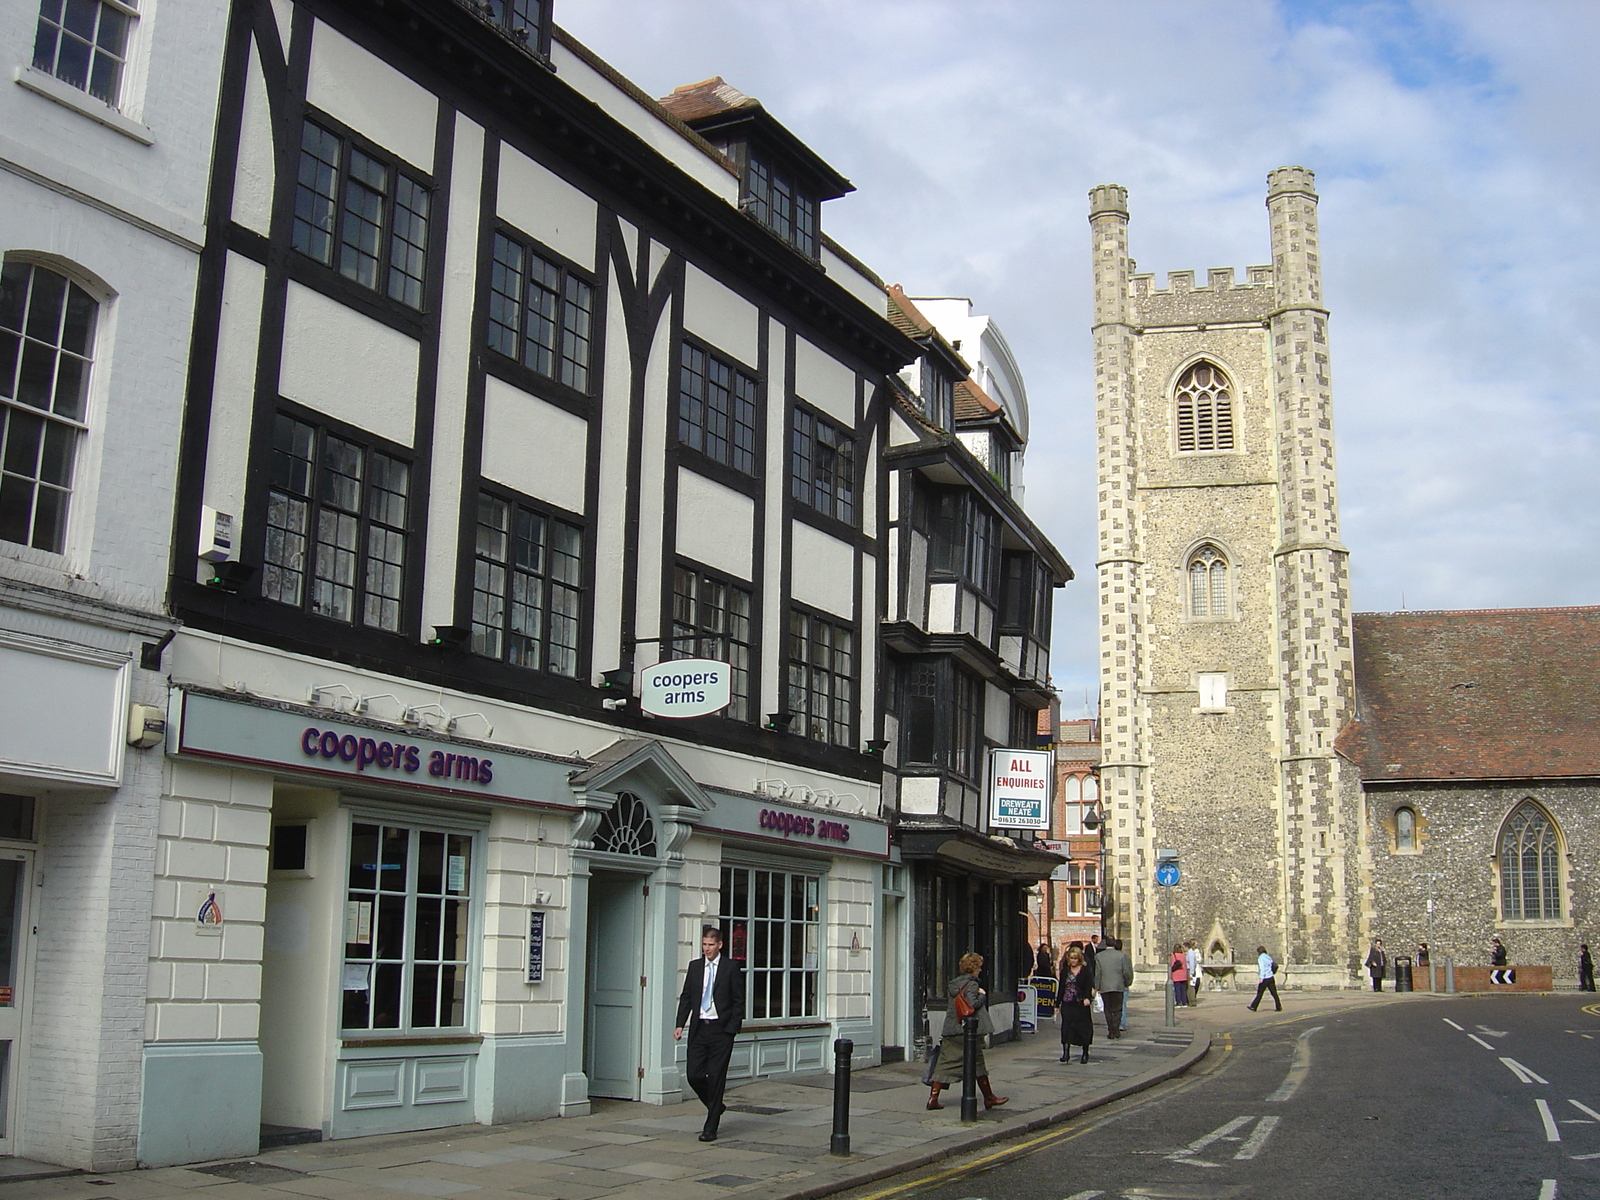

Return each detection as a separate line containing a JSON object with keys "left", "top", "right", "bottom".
{"left": 0, "top": 0, "right": 226, "bottom": 1170}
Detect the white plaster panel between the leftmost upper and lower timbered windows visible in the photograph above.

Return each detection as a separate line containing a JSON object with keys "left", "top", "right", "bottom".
{"left": 278, "top": 281, "right": 419, "bottom": 451}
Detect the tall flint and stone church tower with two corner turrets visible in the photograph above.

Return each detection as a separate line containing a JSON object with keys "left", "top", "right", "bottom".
{"left": 1090, "top": 166, "right": 1363, "bottom": 984}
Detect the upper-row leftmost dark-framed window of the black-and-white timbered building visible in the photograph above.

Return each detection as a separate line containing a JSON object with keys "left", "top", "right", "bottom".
{"left": 291, "top": 120, "right": 432, "bottom": 309}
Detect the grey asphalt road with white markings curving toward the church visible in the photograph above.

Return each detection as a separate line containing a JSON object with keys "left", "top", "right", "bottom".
{"left": 854, "top": 995, "right": 1600, "bottom": 1200}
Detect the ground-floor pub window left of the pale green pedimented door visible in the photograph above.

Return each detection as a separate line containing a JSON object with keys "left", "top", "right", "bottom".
{"left": 341, "top": 821, "right": 472, "bottom": 1030}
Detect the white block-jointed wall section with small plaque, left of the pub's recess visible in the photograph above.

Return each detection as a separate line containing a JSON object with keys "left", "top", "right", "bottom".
{"left": 146, "top": 760, "right": 272, "bottom": 1042}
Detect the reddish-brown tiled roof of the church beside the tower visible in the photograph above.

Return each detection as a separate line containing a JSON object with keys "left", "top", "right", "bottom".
{"left": 1336, "top": 606, "right": 1600, "bottom": 782}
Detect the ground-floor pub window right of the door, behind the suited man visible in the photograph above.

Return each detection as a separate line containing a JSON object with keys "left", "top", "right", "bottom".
{"left": 718, "top": 866, "right": 822, "bottom": 1021}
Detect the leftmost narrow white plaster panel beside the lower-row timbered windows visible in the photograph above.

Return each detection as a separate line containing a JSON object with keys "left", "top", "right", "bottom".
{"left": 195, "top": 253, "right": 267, "bottom": 549}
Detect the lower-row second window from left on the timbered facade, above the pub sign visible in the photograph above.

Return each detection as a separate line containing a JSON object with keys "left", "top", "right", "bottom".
{"left": 472, "top": 491, "right": 584, "bottom": 678}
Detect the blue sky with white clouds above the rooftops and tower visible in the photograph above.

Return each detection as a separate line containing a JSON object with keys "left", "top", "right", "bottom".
{"left": 555, "top": 0, "right": 1600, "bottom": 718}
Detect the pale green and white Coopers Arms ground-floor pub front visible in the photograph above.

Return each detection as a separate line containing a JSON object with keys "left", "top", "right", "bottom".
{"left": 139, "top": 690, "right": 888, "bottom": 1165}
